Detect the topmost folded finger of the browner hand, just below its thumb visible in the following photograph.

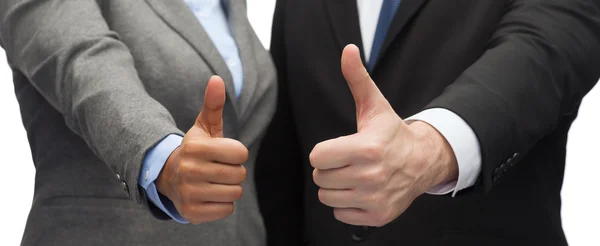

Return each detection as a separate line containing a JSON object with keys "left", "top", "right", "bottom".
{"left": 181, "top": 138, "right": 248, "bottom": 165}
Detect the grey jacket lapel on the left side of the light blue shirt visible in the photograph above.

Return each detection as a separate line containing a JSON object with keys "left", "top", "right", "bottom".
{"left": 146, "top": 0, "right": 237, "bottom": 109}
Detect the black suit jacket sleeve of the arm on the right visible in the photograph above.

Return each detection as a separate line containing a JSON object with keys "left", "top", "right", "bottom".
{"left": 427, "top": 0, "right": 600, "bottom": 192}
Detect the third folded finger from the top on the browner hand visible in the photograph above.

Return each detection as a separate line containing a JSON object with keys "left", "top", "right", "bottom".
{"left": 189, "top": 183, "right": 242, "bottom": 202}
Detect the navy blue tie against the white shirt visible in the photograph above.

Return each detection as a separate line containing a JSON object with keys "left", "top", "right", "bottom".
{"left": 367, "top": 0, "right": 401, "bottom": 71}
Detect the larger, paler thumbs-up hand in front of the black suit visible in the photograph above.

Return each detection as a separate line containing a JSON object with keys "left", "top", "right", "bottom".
{"left": 310, "top": 45, "right": 458, "bottom": 226}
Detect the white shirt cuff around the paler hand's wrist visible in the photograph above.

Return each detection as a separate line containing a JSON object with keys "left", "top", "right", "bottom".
{"left": 406, "top": 108, "right": 481, "bottom": 197}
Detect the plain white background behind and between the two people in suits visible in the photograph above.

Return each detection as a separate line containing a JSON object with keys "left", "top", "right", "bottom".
{"left": 0, "top": 0, "right": 600, "bottom": 246}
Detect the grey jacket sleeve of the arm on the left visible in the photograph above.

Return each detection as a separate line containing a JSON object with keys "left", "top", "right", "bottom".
{"left": 0, "top": 0, "right": 183, "bottom": 204}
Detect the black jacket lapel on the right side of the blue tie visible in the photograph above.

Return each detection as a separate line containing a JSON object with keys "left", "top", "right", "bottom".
{"left": 374, "top": 0, "right": 428, "bottom": 66}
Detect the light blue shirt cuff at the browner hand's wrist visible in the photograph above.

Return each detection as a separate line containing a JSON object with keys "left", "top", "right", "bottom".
{"left": 139, "top": 134, "right": 188, "bottom": 224}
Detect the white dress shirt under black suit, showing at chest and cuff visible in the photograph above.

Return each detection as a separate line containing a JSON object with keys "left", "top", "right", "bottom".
{"left": 356, "top": 0, "right": 481, "bottom": 196}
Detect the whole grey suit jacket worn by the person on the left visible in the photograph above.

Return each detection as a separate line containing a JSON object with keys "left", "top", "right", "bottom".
{"left": 0, "top": 0, "right": 276, "bottom": 246}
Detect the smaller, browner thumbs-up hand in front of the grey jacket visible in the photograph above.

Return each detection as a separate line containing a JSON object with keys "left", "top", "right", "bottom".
{"left": 156, "top": 76, "right": 248, "bottom": 224}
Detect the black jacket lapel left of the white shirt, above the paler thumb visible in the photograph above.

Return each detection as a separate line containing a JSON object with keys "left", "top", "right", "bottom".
{"left": 324, "top": 0, "right": 365, "bottom": 63}
